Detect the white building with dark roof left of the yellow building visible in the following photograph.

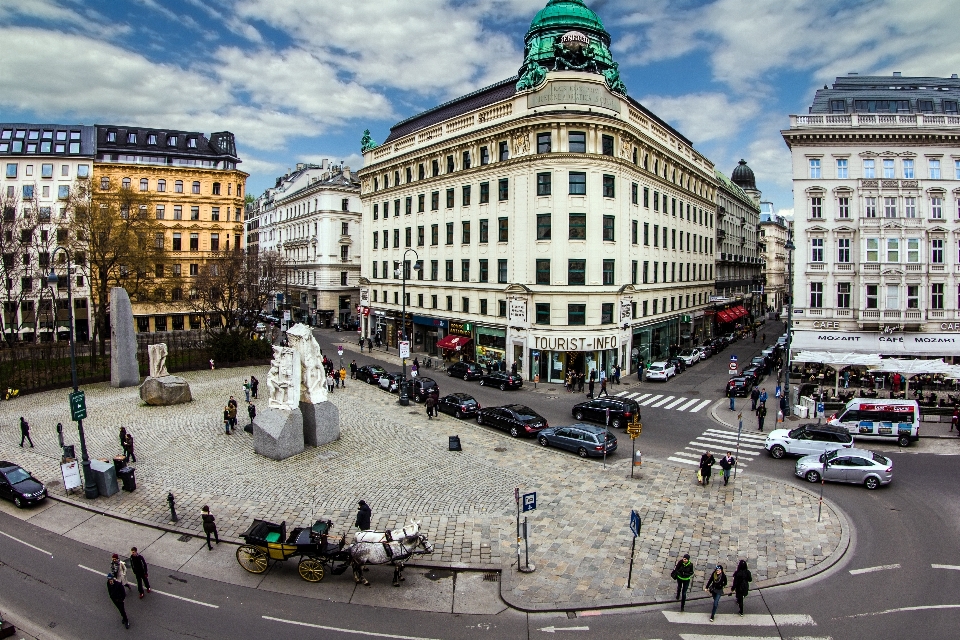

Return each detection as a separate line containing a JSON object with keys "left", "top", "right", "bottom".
{"left": 0, "top": 123, "right": 96, "bottom": 342}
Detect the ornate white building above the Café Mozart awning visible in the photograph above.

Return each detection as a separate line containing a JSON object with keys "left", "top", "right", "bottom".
{"left": 782, "top": 74, "right": 960, "bottom": 356}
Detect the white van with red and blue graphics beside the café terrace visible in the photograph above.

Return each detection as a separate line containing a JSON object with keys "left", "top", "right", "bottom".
{"left": 827, "top": 398, "right": 920, "bottom": 447}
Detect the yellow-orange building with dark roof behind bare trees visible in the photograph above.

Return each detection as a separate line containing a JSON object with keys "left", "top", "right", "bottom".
{"left": 94, "top": 125, "right": 248, "bottom": 333}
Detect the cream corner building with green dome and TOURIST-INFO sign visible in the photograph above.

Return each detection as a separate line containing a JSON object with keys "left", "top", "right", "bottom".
{"left": 359, "top": 0, "right": 716, "bottom": 382}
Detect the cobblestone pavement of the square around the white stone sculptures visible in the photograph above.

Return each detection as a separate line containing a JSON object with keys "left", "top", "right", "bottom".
{"left": 0, "top": 367, "right": 845, "bottom": 609}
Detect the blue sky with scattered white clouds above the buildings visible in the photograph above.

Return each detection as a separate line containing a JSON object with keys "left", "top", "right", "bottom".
{"left": 0, "top": 0, "right": 960, "bottom": 213}
